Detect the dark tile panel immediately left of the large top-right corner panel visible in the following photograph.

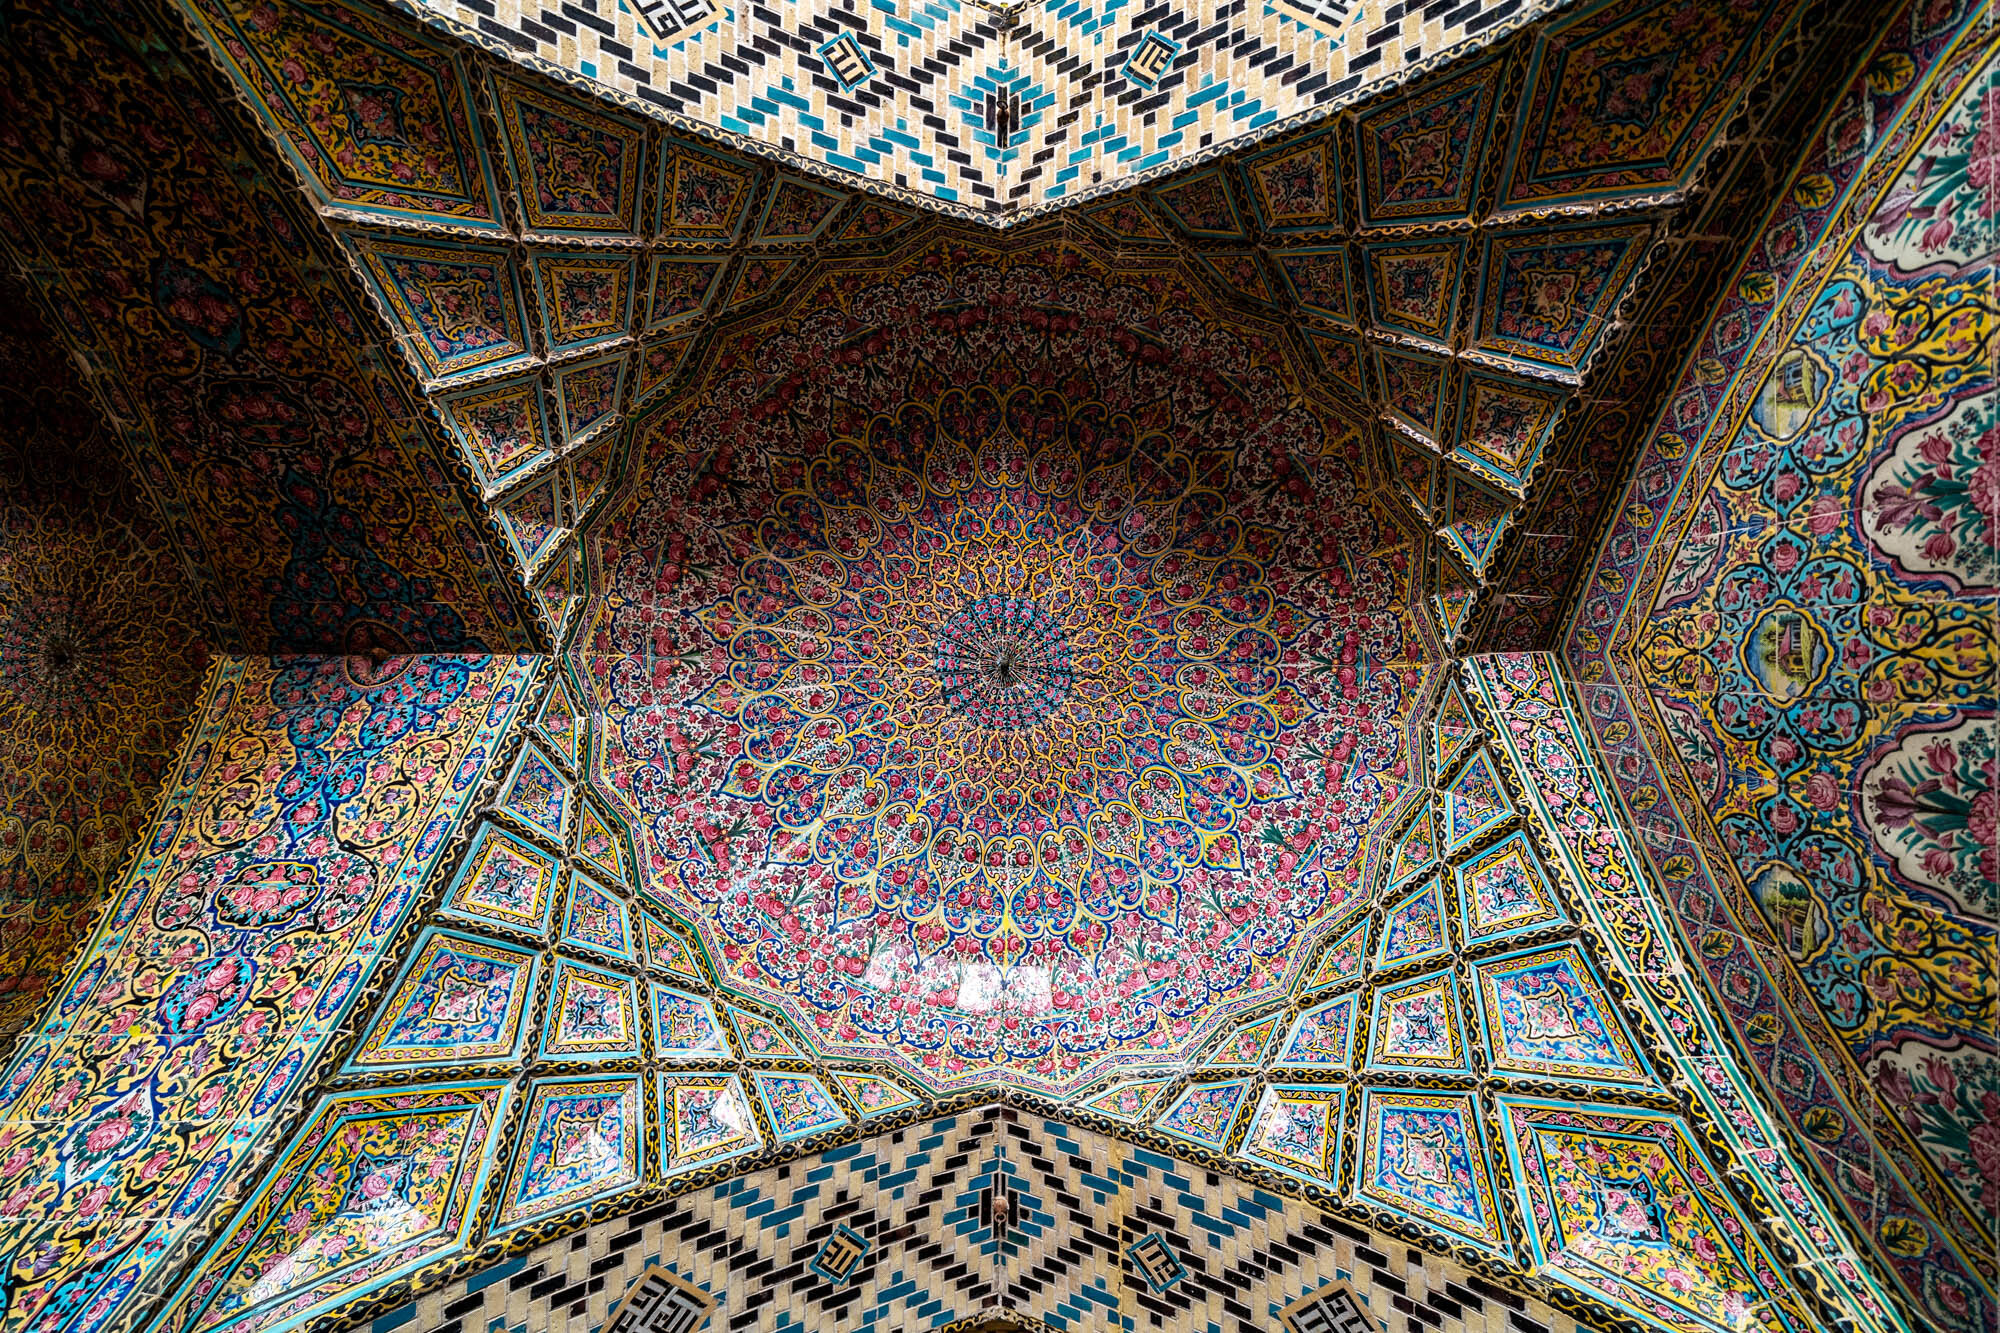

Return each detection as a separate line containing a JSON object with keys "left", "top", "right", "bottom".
{"left": 1354, "top": 60, "right": 1502, "bottom": 226}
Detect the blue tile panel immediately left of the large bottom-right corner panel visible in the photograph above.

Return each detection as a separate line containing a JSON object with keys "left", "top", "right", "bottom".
{"left": 1354, "top": 1089, "right": 1512, "bottom": 1255}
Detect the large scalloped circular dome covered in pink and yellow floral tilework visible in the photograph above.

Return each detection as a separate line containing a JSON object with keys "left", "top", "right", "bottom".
{"left": 584, "top": 246, "right": 1422, "bottom": 1095}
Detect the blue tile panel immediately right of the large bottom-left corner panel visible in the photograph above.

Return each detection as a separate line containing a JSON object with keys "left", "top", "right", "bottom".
{"left": 494, "top": 1075, "right": 644, "bottom": 1231}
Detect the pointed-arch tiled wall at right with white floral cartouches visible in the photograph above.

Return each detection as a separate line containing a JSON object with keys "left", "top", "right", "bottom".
{"left": 1566, "top": 6, "right": 2000, "bottom": 1329}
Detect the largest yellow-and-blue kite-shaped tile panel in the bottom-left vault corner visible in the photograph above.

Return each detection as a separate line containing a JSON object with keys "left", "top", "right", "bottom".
{"left": 166, "top": 1083, "right": 508, "bottom": 1327}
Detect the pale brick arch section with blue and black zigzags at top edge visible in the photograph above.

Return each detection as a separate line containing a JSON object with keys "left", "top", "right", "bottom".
{"left": 406, "top": 0, "right": 1558, "bottom": 220}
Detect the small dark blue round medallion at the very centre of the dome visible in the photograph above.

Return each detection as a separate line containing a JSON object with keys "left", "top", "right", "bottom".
{"left": 938, "top": 596, "right": 1076, "bottom": 731}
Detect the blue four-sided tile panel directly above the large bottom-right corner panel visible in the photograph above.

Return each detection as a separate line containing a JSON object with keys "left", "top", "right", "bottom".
{"left": 1472, "top": 932, "right": 1650, "bottom": 1083}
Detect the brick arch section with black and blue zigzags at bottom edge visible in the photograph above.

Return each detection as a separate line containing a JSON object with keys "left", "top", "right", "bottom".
{"left": 390, "top": 1105, "right": 1580, "bottom": 1333}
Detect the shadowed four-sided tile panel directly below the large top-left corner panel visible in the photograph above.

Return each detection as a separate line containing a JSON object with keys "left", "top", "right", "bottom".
{"left": 342, "top": 232, "right": 530, "bottom": 380}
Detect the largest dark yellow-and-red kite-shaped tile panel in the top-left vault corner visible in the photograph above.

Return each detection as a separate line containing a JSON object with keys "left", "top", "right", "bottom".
{"left": 182, "top": 2, "right": 500, "bottom": 230}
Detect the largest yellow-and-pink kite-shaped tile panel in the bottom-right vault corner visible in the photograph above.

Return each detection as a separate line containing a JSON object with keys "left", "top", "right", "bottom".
{"left": 1500, "top": 1097, "right": 1816, "bottom": 1333}
